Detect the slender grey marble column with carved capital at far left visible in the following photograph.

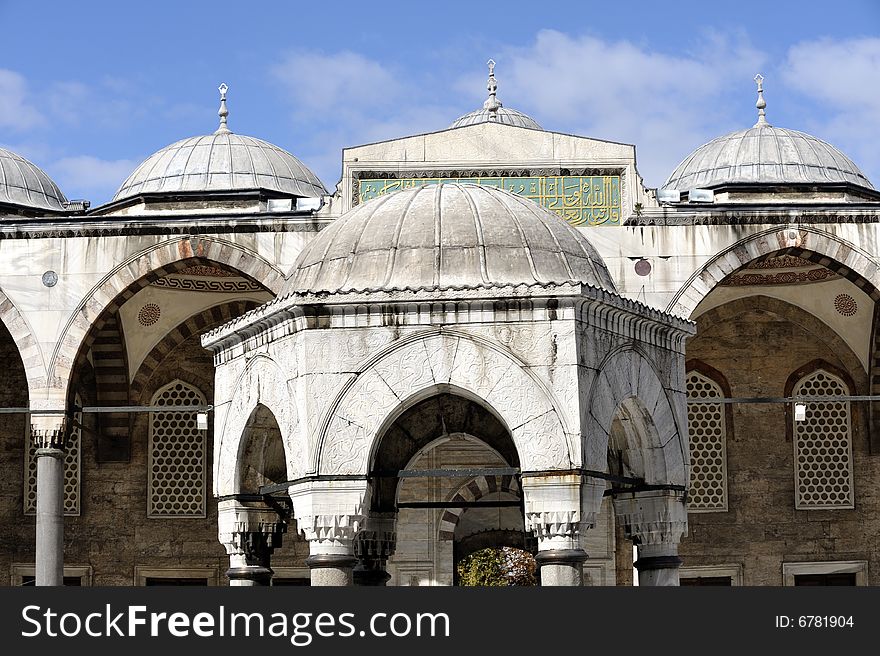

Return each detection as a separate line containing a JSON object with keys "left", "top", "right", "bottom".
{"left": 31, "top": 415, "right": 68, "bottom": 585}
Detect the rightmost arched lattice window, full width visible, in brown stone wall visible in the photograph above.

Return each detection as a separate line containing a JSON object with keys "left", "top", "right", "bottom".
{"left": 792, "top": 369, "right": 854, "bottom": 510}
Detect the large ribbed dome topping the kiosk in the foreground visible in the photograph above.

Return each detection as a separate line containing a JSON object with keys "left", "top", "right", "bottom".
{"left": 285, "top": 183, "right": 614, "bottom": 293}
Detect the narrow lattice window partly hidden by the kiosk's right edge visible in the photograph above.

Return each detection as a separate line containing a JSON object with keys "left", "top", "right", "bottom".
{"left": 687, "top": 371, "right": 727, "bottom": 512}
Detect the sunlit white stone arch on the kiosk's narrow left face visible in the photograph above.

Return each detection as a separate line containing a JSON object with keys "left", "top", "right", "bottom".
{"left": 214, "top": 355, "right": 308, "bottom": 496}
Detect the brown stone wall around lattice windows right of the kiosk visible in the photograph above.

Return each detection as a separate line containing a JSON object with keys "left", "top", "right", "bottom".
{"left": 680, "top": 296, "right": 880, "bottom": 585}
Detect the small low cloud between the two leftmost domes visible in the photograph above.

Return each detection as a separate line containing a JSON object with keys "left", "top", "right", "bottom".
{"left": 47, "top": 155, "right": 138, "bottom": 206}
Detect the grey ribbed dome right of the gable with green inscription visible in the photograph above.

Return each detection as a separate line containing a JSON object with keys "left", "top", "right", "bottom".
{"left": 663, "top": 124, "right": 873, "bottom": 191}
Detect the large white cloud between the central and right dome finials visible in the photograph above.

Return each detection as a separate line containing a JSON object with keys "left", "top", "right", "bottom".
{"left": 497, "top": 30, "right": 764, "bottom": 186}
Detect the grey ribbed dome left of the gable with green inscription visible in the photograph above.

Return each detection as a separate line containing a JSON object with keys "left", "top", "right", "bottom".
{"left": 113, "top": 132, "right": 327, "bottom": 201}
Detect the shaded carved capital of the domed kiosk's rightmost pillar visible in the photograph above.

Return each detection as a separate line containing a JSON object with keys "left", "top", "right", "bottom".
{"left": 614, "top": 490, "right": 687, "bottom": 547}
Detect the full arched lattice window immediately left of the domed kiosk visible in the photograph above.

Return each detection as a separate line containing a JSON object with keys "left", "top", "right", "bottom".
{"left": 147, "top": 380, "right": 205, "bottom": 517}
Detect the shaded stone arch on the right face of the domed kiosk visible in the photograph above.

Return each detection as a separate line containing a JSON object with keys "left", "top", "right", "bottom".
{"left": 584, "top": 348, "right": 689, "bottom": 485}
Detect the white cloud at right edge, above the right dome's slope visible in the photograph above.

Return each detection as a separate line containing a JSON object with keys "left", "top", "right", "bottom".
{"left": 782, "top": 37, "right": 880, "bottom": 186}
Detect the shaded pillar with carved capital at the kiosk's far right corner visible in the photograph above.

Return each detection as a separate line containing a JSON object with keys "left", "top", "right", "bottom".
{"left": 614, "top": 490, "right": 687, "bottom": 586}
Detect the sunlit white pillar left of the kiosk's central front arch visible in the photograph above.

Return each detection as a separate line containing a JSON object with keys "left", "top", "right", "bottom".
{"left": 288, "top": 480, "right": 370, "bottom": 586}
